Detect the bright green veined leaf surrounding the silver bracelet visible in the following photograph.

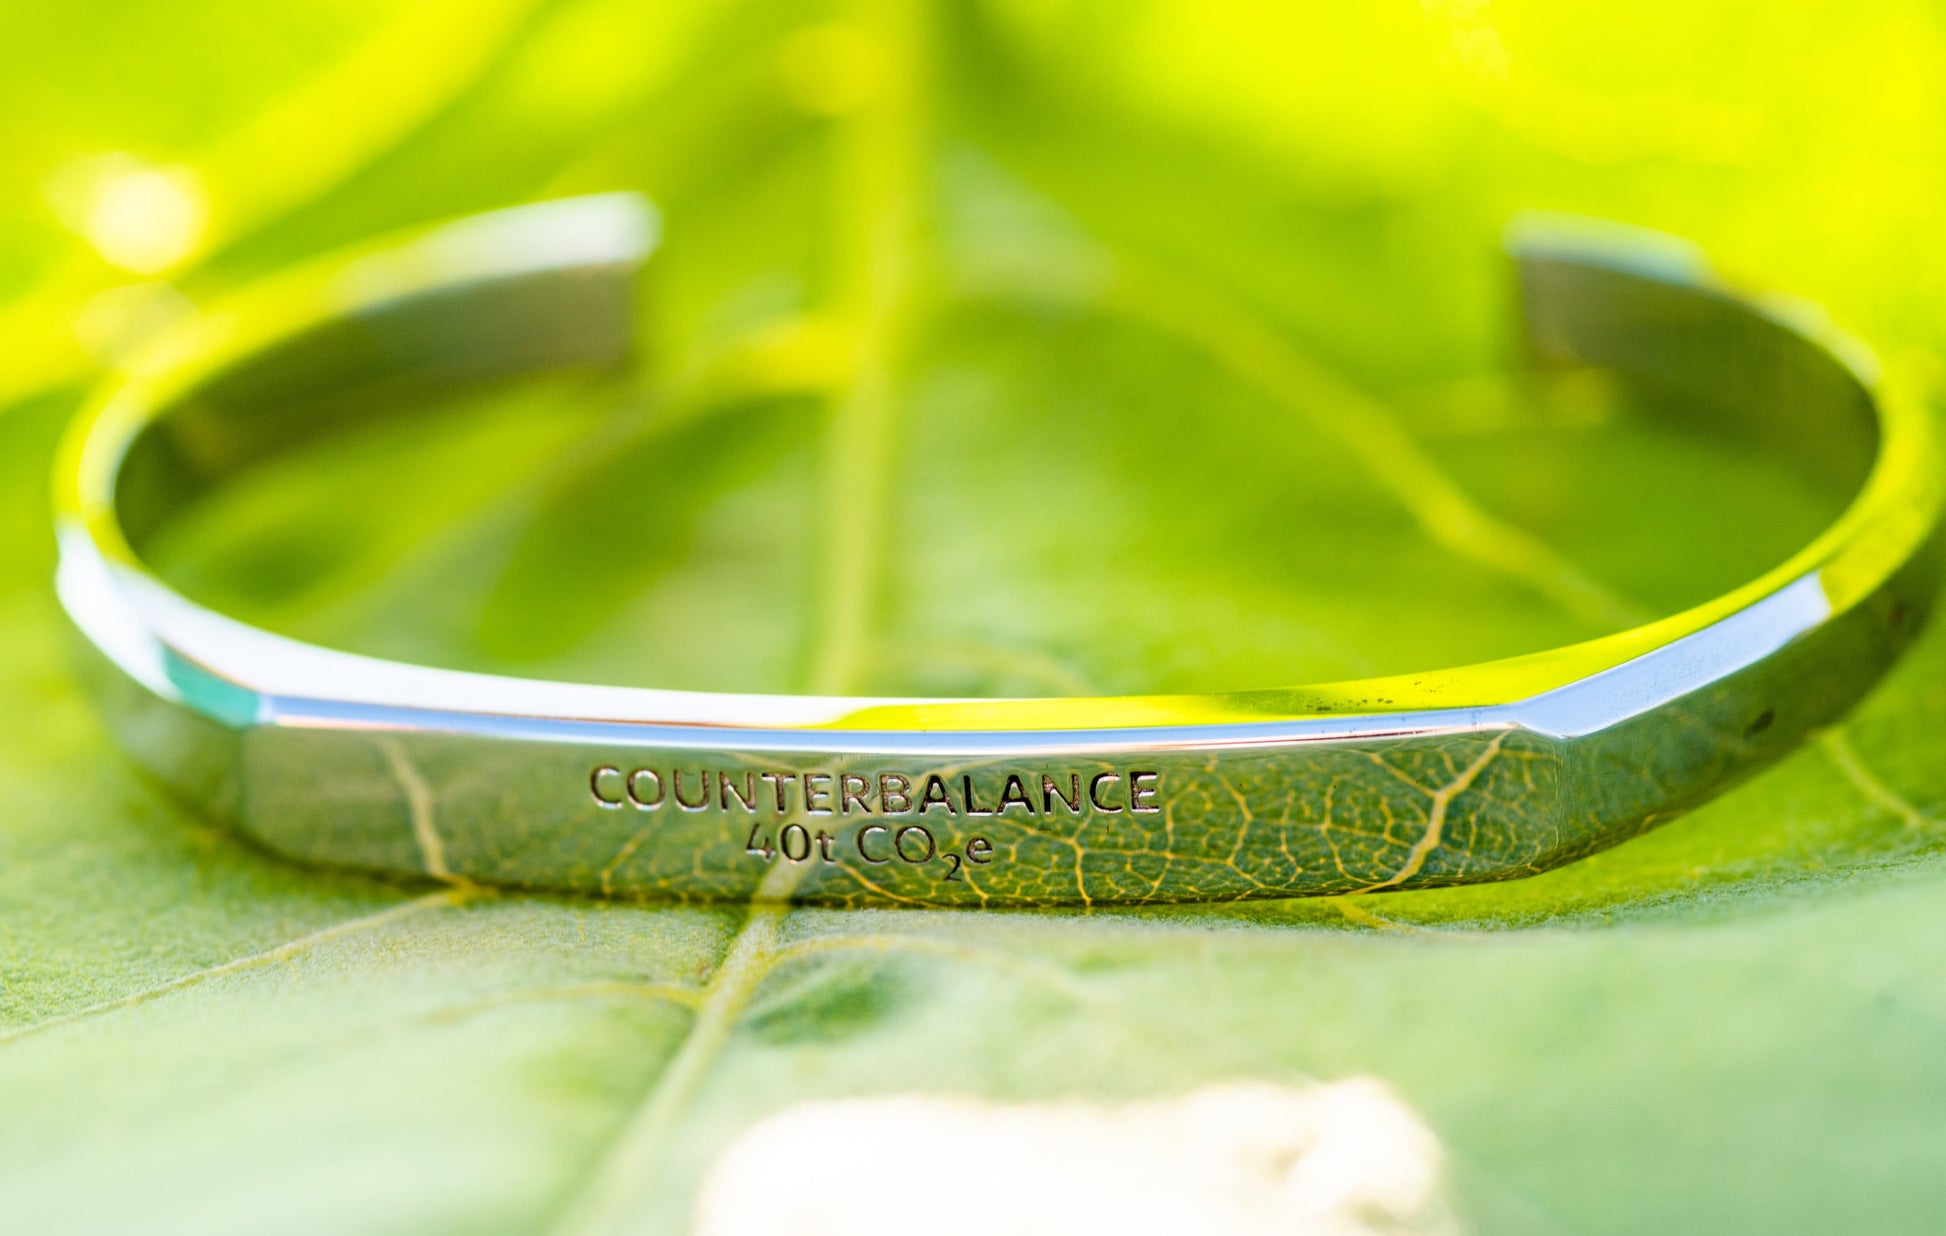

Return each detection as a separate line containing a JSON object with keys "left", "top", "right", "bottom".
{"left": 0, "top": 0, "right": 1946, "bottom": 1232}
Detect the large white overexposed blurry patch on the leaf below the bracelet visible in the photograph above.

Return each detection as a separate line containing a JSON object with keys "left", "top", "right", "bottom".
{"left": 695, "top": 1078, "right": 1456, "bottom": 1236}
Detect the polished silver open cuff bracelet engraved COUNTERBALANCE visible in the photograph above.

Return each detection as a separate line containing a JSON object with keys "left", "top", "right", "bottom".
{"left": 56, "top": 195, "right": 1940, "bottom": 905}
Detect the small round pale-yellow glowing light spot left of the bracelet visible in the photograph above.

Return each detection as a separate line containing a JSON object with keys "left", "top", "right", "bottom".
{"left": 49, "top": 154, "right": 210, "bottom": 274}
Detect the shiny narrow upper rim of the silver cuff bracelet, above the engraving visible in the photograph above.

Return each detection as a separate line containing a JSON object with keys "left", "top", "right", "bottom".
{"left": 54, "top": 195, "right": 1942, "bottom": 753}
